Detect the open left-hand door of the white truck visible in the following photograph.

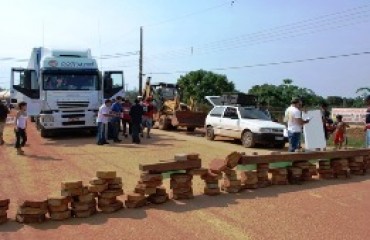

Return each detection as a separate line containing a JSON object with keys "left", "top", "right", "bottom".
{"left": 10, "top": 68, "right": 41, "bottom": 116}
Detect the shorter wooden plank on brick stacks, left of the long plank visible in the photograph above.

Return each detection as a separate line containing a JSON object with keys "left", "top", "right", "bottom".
{"left": 139, "top": 159, "right": 202, "bottom": 173}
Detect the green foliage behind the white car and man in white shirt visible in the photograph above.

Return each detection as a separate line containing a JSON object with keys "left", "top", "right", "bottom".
{"left": 248, "top": 79, "right": 324, "bottom": 108}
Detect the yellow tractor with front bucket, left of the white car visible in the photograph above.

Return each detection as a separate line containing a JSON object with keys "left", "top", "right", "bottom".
{"left": 143, "top": 77, "right": 207, "bottom": 132}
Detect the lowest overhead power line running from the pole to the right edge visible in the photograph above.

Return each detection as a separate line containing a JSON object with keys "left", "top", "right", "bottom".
{"left": 146, "top": 52, "right": 370, "bottom": 75}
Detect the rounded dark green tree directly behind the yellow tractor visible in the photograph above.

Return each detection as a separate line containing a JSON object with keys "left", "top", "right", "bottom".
{"left": 177, "top": 70, "right": 235, "bottom": 103}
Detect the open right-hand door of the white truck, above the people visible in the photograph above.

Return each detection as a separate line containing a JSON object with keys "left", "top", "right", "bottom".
{"left": 103, "top": 71, "right": 125, "bottom": 99}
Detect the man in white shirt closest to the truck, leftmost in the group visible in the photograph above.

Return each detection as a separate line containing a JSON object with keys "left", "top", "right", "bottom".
{"left": 96, "top": 99, "right": 112, "bottom": 145}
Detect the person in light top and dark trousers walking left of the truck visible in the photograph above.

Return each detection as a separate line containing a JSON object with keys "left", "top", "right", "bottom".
{"left": 14, "top": 102, "right": 27, "bottom": 155}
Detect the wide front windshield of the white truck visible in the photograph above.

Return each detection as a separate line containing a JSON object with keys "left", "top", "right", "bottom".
{"left": 43, "top": 73, "right": 99, "bottom": 91}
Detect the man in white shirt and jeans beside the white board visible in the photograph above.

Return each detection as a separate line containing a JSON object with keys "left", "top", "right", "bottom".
{"left": 285, "top": 98, "right": 309, "bottom": 152}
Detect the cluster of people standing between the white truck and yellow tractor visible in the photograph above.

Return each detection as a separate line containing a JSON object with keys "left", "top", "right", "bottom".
{"left": 97, "top": 96, "right": 155, "bottom": 145}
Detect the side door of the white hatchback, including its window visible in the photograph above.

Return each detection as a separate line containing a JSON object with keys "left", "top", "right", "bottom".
{"left": 221, "top": 107, "right": 240, "bottom": 138}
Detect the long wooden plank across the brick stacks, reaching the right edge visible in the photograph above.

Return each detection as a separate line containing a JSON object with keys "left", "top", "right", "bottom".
{"left": 239, "top": 149, "right": 370, "bottom": 165}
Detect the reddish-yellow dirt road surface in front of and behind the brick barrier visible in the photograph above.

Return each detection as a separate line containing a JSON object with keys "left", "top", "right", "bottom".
{"left": 0, "top": 123, "right": 370, "bottom": 240}
